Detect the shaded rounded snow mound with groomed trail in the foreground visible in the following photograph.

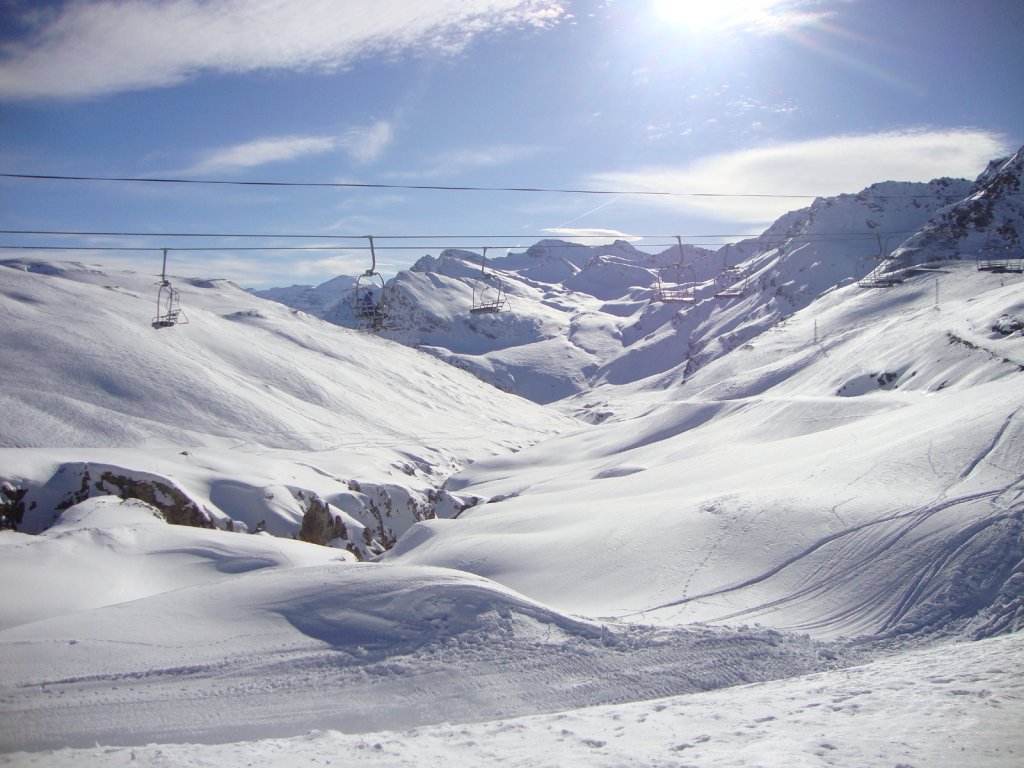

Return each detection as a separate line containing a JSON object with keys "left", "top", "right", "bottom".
{"left": 0, "top": 563, "right": 836, "bottom": 751}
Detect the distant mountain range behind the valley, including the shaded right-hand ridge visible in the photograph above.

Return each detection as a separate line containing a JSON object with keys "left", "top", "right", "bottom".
{"left": 253, "top": 172, "right": 991, "bottom": 403}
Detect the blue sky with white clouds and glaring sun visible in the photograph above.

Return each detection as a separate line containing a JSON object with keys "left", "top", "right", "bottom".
{"left": 0, "top": 0, "right": 1024, "bottom": 288}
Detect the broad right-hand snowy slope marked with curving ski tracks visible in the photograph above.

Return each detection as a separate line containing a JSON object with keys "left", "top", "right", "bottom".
{"left": 388, "top": 263, "right": 1024, "bottom": 637}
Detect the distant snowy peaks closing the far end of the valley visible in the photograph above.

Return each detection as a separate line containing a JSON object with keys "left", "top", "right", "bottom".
{"left": 385, "top": 241, "right": 702, "bottom": 402}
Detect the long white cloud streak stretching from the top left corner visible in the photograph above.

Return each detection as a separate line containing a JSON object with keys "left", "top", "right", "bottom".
{"left": 0, "top": 0, "right": 565, "bottom": 99}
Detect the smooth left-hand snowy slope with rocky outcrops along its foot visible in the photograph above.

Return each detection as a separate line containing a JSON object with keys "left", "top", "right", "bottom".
{"left": 0, "top": 261, "right": 565, "bottom": 556}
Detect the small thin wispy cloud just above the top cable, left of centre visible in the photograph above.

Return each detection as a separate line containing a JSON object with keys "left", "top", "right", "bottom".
{"left": 180, "top": 121, "right": 393, "bottom": 175}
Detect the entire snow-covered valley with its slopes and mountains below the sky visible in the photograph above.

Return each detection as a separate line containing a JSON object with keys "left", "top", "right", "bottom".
{"left": 0, "top": 150, "right": 1024, "bottom": 767}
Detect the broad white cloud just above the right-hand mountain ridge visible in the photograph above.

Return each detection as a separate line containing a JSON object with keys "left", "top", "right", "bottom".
{"left": 587, "top": 129, "right": 1009, "bottom": 225}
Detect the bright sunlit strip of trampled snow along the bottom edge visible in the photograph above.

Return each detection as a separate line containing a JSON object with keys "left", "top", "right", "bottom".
{"left": 0, "top": 634, "right": 1024, "bottom": 768}
